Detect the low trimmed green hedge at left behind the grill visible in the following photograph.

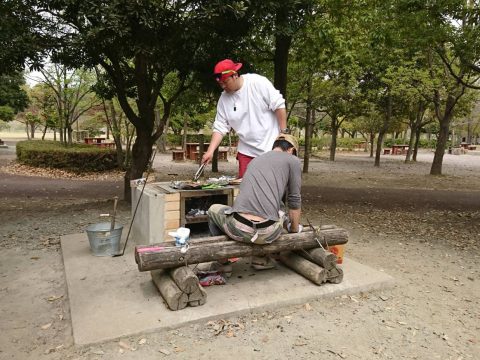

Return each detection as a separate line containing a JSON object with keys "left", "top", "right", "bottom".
{"left": 16, "top": 140, "right": 117, "bottom": 173}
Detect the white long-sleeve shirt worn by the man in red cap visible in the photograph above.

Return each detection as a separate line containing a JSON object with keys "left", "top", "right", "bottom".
{"left": 213, "top": 74, "right": 285, "bottom": 157}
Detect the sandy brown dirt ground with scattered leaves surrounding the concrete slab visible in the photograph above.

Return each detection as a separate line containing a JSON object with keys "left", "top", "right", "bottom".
{"left": 0, "top": 142, "right": 480, "bottom": 360}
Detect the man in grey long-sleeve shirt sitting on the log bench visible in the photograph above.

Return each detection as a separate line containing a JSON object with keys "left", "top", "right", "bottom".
{"left": 208, "top": 134, "right": 302, "bottom": 270}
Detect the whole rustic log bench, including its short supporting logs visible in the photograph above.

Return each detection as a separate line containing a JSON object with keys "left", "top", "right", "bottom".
{"left": 135, "top": 225, "right": 348, "bottom": 310}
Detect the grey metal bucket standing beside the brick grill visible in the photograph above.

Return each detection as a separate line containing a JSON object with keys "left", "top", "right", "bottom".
{"left": 86, "top": 223, "right": 123, "bottom": 256}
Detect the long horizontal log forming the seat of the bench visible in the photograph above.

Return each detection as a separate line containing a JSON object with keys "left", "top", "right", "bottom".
{"left": 135, "top": 228, "right": 348, "bottom": 271}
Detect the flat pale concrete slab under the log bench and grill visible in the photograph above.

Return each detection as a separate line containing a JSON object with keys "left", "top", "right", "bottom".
{"left": 61, "top": 234, "right": 394, "bottom": 345}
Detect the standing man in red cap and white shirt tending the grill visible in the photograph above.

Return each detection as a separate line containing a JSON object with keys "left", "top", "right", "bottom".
{"left": 202, "top": 59, "right": 289, "bottom": 178}
